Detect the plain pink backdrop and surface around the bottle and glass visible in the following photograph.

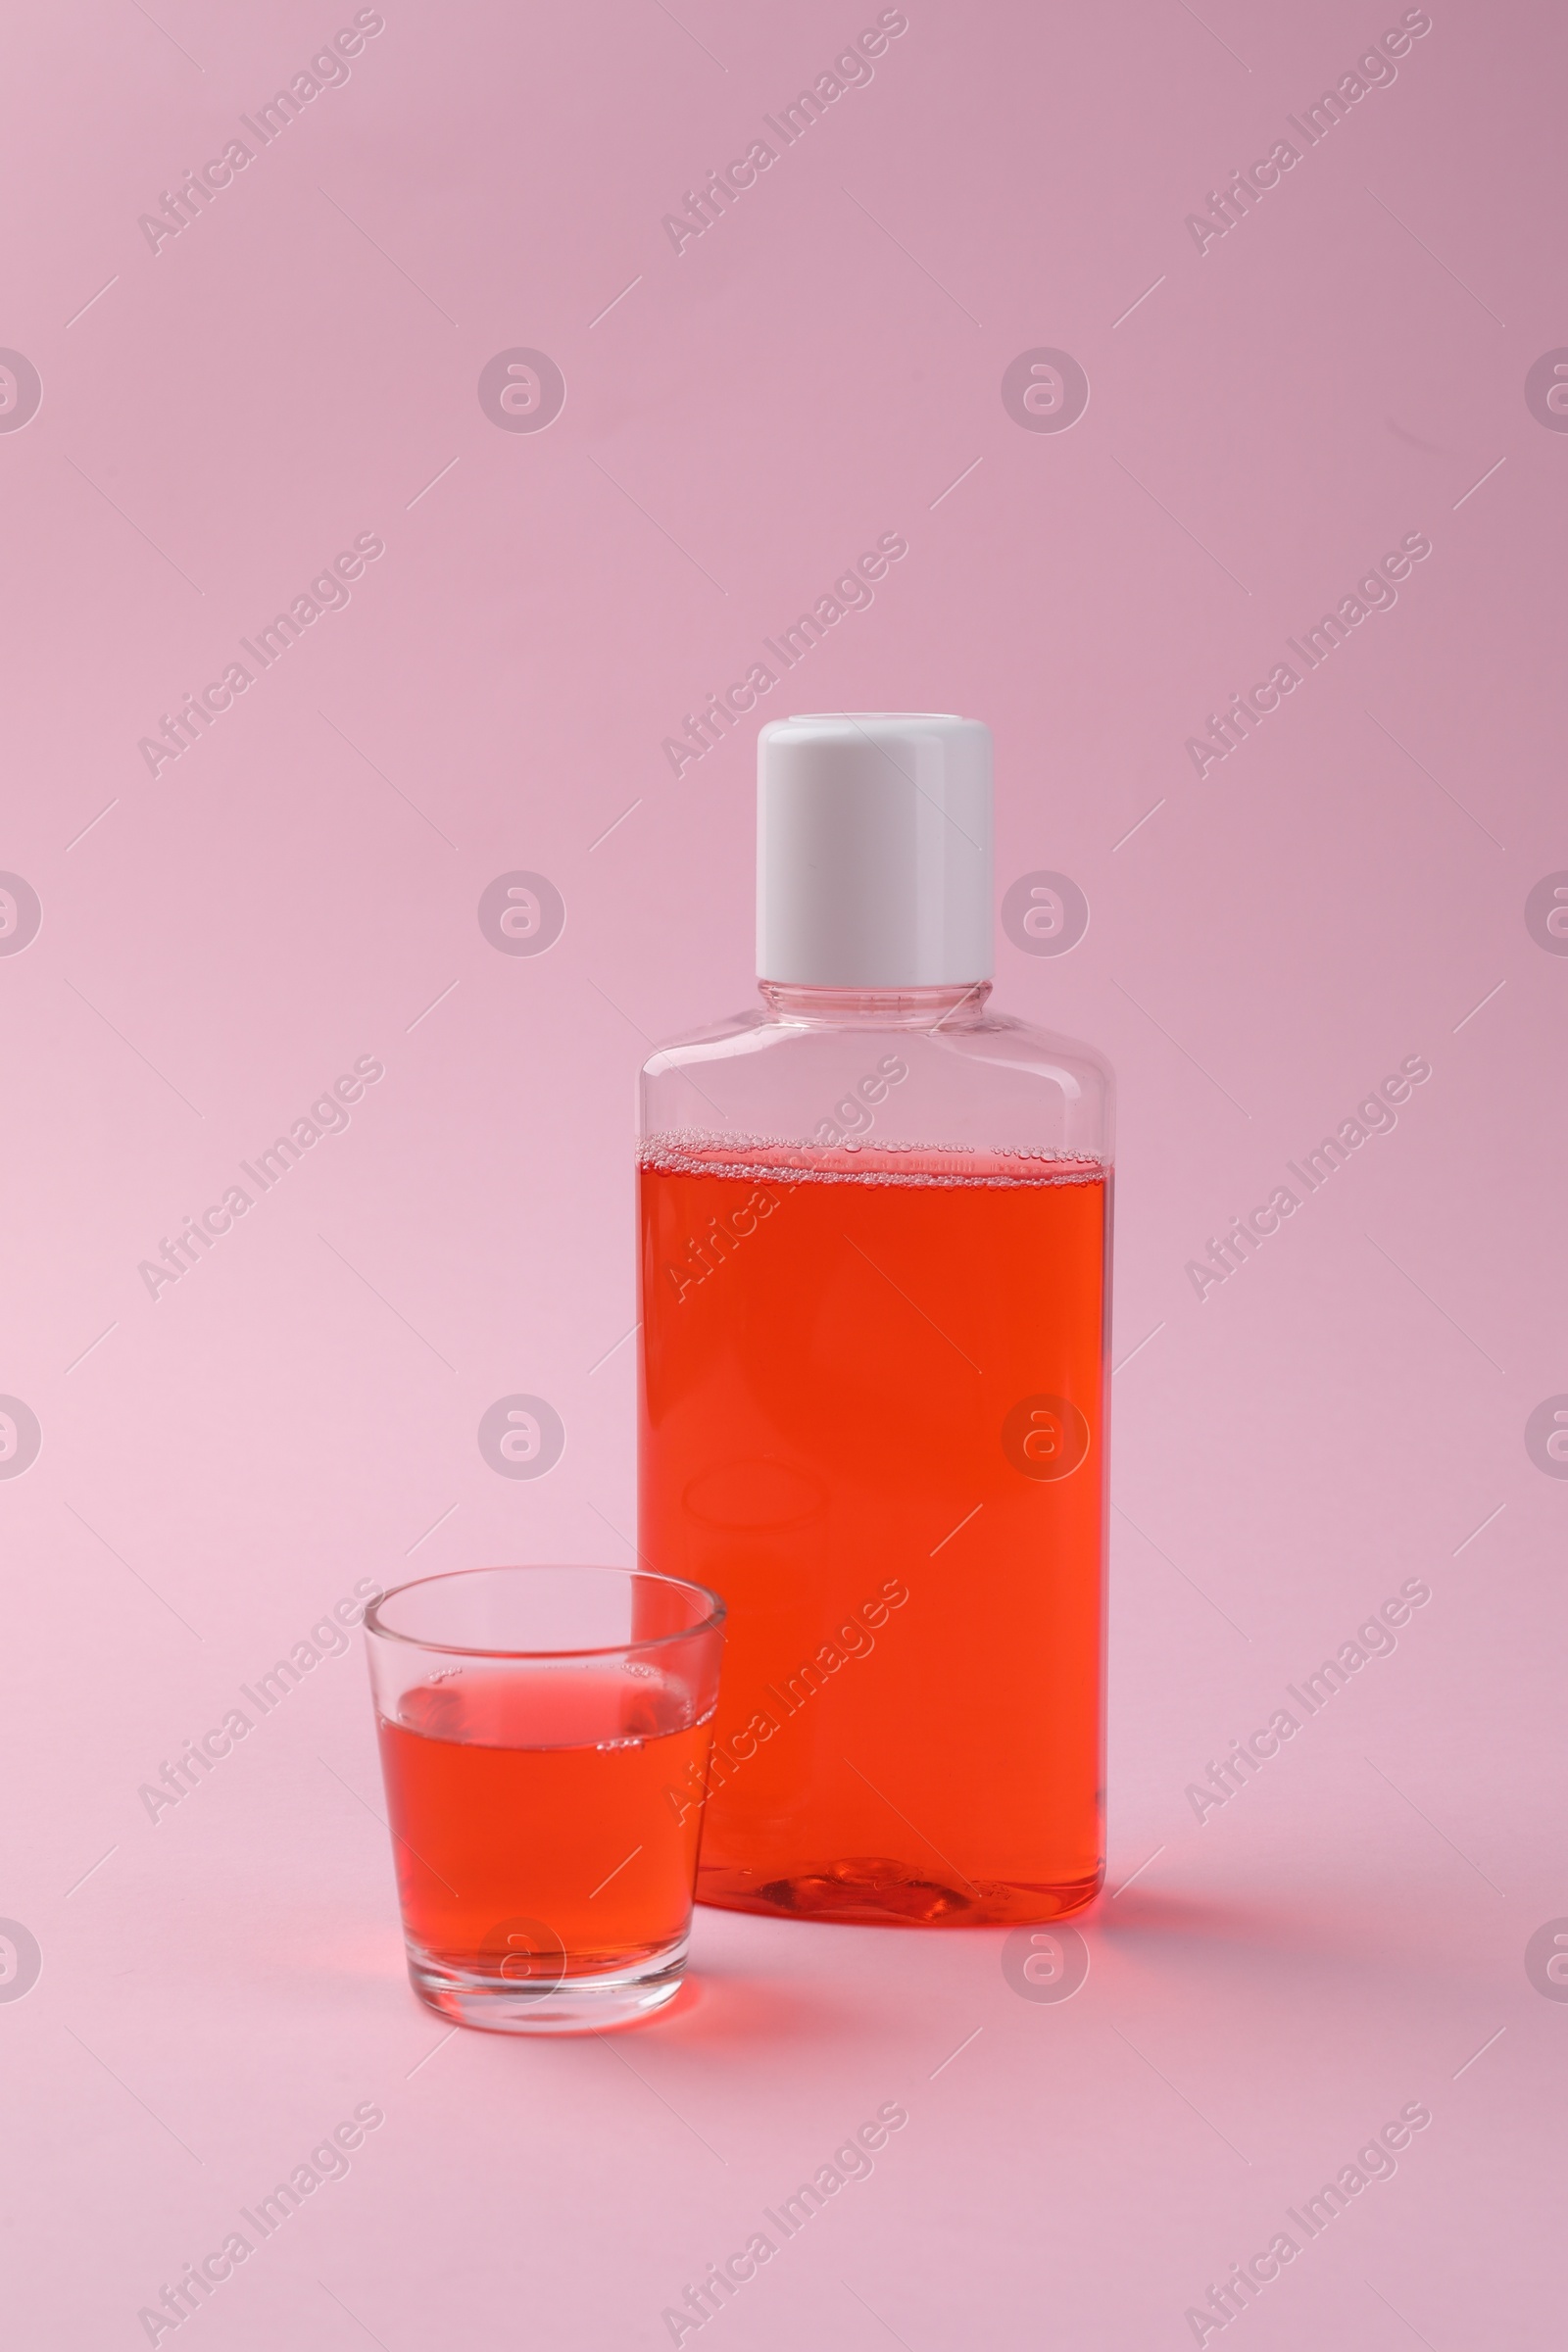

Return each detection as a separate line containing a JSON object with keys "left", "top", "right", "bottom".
{"left": 0, "top": 0, "right": 1568, "bottom": 2352}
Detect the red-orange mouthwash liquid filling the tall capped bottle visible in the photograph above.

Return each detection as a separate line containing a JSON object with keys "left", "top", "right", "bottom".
{"left": 639, "top": 1139, "right": 1107, "bottom": 1924}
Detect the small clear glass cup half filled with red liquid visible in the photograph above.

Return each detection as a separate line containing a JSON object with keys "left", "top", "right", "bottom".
{"left": 365, "top": 1566, "right": 724, "bottom": 2034}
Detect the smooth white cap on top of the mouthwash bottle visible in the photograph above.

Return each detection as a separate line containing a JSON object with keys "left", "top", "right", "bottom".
{"left": 757, "top": 710, "right": 995, "bottom": 988}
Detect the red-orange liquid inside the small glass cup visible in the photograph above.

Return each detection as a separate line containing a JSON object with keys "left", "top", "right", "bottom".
{"left": 378, "top": 1663, "right": 712, "bottom": 1987}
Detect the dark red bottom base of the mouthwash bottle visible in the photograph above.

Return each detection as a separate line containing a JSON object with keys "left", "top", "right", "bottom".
{"left": 696, "top": 1856, "right": 1104, "bottom": 1927}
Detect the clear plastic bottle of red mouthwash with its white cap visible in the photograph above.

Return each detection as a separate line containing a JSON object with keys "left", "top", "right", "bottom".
{"left": 639, "top": 712, "right": 1112, "bottom": 1924}
